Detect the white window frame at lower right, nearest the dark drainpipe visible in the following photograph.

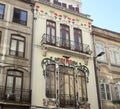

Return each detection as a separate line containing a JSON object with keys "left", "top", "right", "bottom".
{"left": 99, "top": 79, "right": 112, "bottom": 101}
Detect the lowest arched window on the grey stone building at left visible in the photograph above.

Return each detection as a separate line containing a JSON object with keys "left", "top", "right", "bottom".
{"left": 5, "top": 70, "right": 23, "bottom": 100}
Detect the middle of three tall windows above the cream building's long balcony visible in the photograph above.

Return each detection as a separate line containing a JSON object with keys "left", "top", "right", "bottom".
{"left": 60, "top": 24, "right": 70, "bottom": 48}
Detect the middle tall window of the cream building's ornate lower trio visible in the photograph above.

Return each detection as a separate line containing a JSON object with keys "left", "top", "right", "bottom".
{"left": 59, "top": 66, "right": 75, "bottom": 107}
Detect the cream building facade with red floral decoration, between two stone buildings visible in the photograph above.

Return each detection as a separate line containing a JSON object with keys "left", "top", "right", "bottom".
{"left": 31, "top": 0, "right": 98, "bottom": 109}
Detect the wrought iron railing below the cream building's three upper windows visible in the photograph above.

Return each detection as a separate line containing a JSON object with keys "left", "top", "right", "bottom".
{"left": 41, "top": 34, "right": 92, "bottom": 55}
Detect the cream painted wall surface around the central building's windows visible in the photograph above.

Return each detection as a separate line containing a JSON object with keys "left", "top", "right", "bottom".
{"left": 32, "top": 1, "right": 98, "bottom": 109}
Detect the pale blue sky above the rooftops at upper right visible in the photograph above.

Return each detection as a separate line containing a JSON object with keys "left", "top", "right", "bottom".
{"left": 81, "top": 0, "right": 120, "bottom": 33}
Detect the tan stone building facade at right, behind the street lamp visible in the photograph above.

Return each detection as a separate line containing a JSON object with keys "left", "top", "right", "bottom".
{"left": 92, "top": 26, "right": 120, "bottom": 109}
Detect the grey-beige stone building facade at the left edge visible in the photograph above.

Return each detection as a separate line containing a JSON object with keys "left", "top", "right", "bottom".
{"left": 0, "top": 0, "right": 33, "bottom": 109}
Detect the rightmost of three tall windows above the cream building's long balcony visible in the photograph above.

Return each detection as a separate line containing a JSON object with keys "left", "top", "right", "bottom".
{"left": 74, "top": 28, "right": 82, "bottom": 51}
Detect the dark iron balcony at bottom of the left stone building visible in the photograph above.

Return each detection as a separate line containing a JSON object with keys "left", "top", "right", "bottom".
{"left": 0, "top": 86, "right": 31, "bottom": 104}
